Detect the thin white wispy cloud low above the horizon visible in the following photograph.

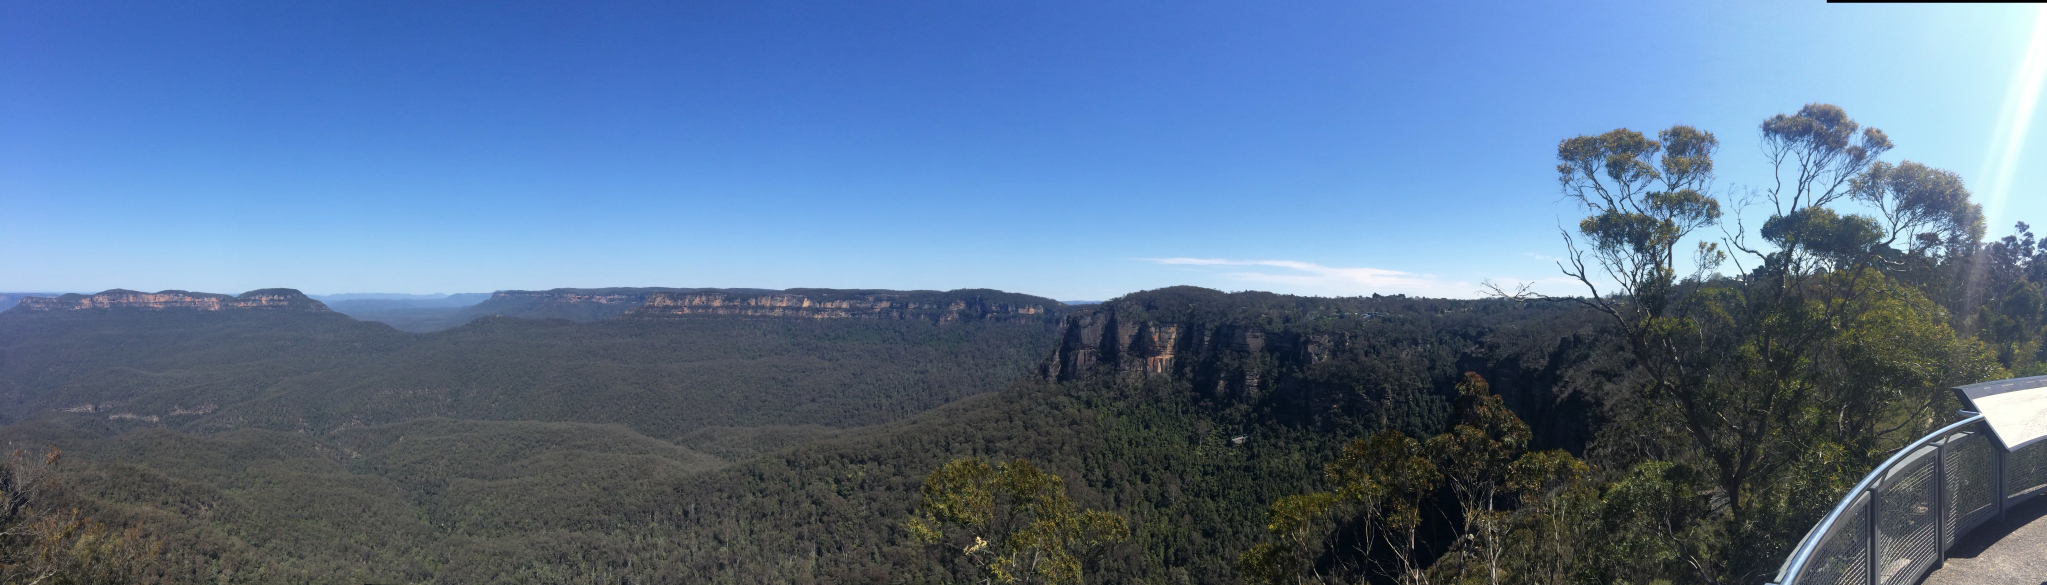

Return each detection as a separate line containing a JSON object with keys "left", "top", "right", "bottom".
{"left": 1138, "top": 258, "right": 1478, "bottom": 299}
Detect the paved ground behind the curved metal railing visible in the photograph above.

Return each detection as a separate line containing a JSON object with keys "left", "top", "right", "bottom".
{"left": 1920, "top": 497, "right": 2047, "bottom": 585}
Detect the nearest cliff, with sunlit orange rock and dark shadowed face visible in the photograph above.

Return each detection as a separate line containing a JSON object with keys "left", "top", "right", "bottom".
{"left": 1038, "top": 286, "right": 1470, "bottom": 436}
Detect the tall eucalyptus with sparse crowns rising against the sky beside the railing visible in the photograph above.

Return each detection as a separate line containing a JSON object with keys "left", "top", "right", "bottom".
{"left": 1556, "top": 104, "right": 1994, "bottom": 581}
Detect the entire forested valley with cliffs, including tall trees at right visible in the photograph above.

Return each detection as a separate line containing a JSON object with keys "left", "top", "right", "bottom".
{"left": 0, "top": 104, "right": 2047, "bottom": 585}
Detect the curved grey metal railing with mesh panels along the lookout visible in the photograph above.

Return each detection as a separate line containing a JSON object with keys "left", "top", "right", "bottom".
{"left": 1771, "top": 413, "right": 2047, "bottom": 585}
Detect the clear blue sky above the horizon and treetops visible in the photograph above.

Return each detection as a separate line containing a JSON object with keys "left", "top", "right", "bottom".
{"left": 0, "top": 0, "right": 2047, "bottom": 299}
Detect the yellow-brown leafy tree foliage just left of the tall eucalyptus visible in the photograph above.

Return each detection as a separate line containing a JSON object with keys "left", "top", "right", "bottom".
{"left": 1238, "top": 372, "right": 1599, "bottom": 583}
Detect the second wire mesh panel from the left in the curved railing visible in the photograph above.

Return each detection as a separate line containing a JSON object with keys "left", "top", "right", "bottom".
{"left": 1877, "top": 448, "right": 1941, "bottom": 585}
